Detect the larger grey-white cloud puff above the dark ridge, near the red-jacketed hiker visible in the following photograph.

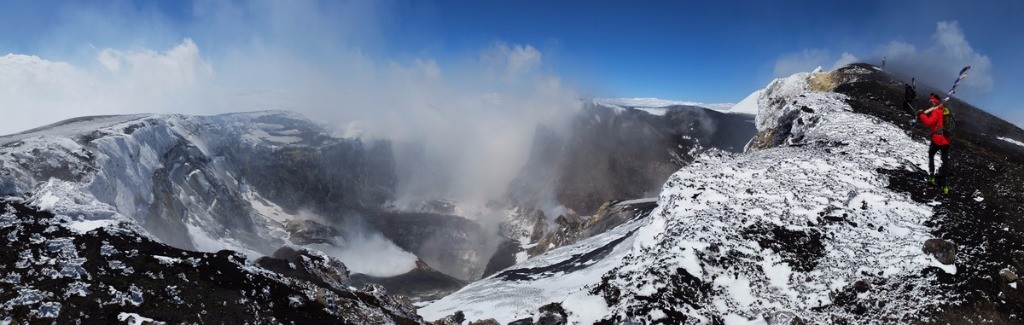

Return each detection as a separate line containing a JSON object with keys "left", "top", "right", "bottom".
{"left": 879, "top": 22, "right": 994, "bottom": 94}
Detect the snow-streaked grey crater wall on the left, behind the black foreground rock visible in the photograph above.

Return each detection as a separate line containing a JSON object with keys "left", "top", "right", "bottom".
{"left": 0, "top": 112, "right": 407, "bottom": 276}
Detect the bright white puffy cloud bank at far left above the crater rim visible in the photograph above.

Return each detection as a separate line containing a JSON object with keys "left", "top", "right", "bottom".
{"left": 0, "top": 39, "right": 212, "bottom": 129}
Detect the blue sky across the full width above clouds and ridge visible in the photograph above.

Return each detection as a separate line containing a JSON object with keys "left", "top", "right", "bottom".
{"left": 0, "top": 0, "right": 1024, "bottom": 124}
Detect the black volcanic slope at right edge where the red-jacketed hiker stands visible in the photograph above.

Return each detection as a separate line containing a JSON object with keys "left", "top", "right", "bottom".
{"left": 815, "top": 64, "right": 1024, "bottom": 324}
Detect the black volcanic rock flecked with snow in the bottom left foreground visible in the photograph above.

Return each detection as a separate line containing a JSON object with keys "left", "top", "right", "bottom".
{"left": 0, "top": 200, "right": 423, "bottom": 324}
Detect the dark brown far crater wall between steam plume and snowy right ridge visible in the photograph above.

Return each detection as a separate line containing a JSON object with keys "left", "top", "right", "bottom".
{"left": 510, "top": 104, "right": 755, "bottom": 217}
